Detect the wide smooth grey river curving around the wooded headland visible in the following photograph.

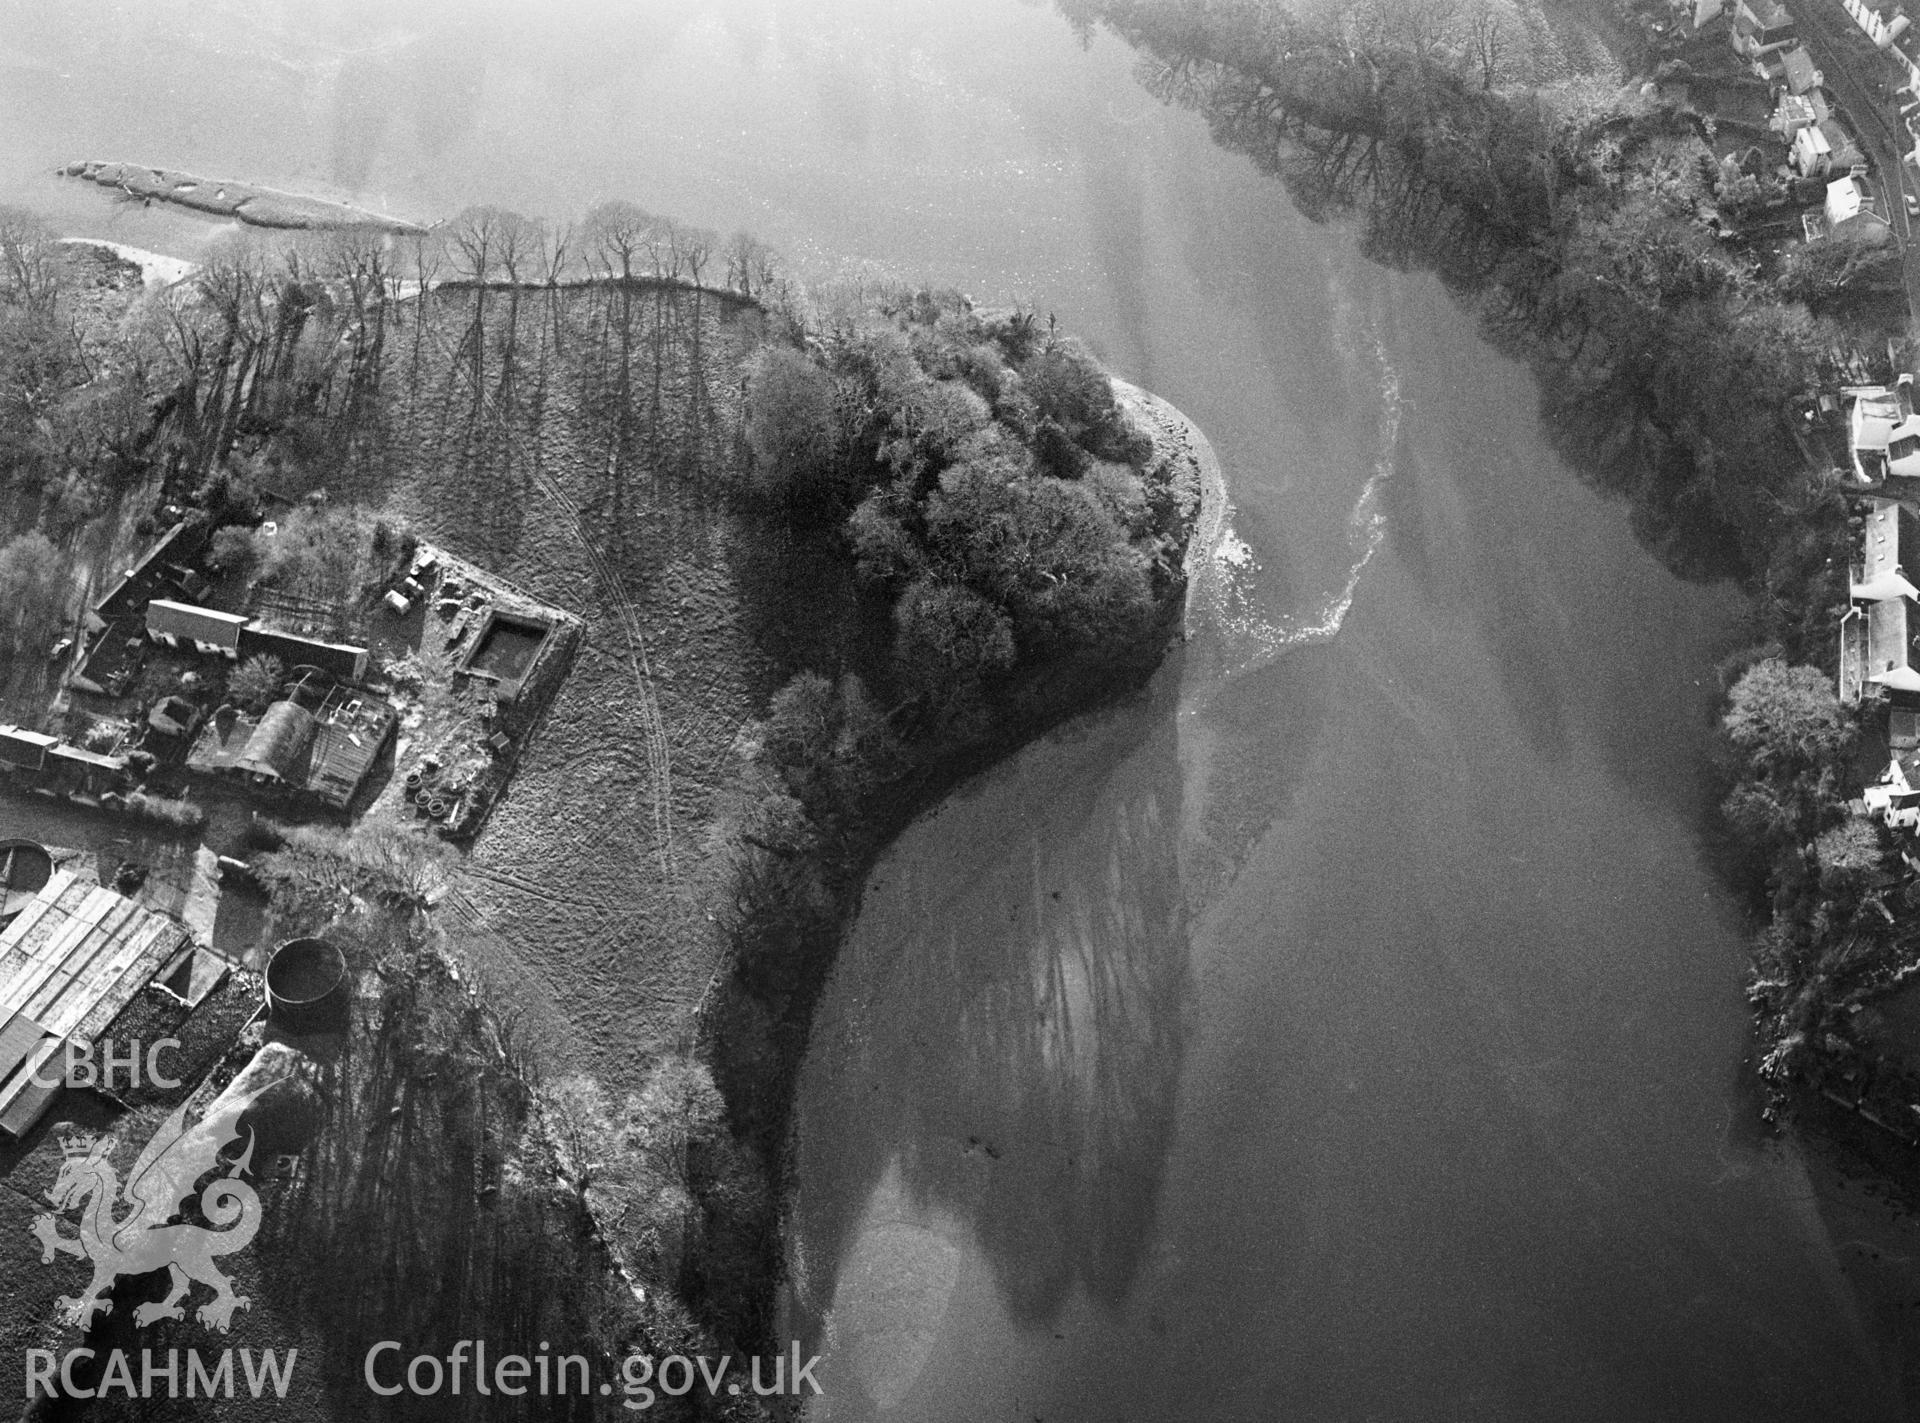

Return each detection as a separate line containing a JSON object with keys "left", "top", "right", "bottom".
{"left": 0, "top": 0, "right": 1903, "bottom": 1423}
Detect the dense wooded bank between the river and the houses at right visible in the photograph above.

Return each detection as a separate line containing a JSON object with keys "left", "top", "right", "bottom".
{"left": 1060, "top": 0, "right": 1920, "bottom": 1106}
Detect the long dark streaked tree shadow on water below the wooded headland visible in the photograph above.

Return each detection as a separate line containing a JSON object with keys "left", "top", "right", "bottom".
{"left": 799, "top": 668, "right": 1190, "bottom": 1327}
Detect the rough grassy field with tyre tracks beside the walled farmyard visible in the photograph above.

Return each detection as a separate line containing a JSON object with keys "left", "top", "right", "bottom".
{"left": 328, "top": 288, "right": 804, "bottom": 1087}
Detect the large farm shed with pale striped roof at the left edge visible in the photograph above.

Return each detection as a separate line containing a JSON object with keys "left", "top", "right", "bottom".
{"left": 0, "top": 870, "right": 192, "bottom": 1139}
